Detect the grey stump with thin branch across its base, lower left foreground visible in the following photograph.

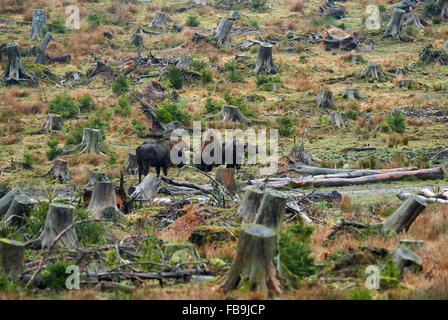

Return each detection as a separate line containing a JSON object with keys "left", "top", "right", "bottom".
{"left": 34, "top": 203, "right": 78, "bottom": 249}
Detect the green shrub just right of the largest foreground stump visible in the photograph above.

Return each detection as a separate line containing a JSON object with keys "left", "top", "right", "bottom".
{"left": 279, "top": 223, "right": 315, "bottom": 277}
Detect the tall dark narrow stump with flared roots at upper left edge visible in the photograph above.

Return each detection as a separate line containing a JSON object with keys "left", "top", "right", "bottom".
{"left": 2, "top": 42, "right": 37, "bottom": 85}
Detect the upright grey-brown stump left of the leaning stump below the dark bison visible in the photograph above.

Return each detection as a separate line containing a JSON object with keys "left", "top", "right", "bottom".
{"left": 87, "top": 182, "right": 118, "bottom": 220}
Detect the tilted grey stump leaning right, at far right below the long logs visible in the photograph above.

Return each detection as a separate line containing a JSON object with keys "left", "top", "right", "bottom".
{"left": 381, "top": 197, "right": 426, "bottom": 235}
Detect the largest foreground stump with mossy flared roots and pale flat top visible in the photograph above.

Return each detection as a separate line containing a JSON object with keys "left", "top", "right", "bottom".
{"left": 220, "top": 224, "right": 281, "bottom": 294}
